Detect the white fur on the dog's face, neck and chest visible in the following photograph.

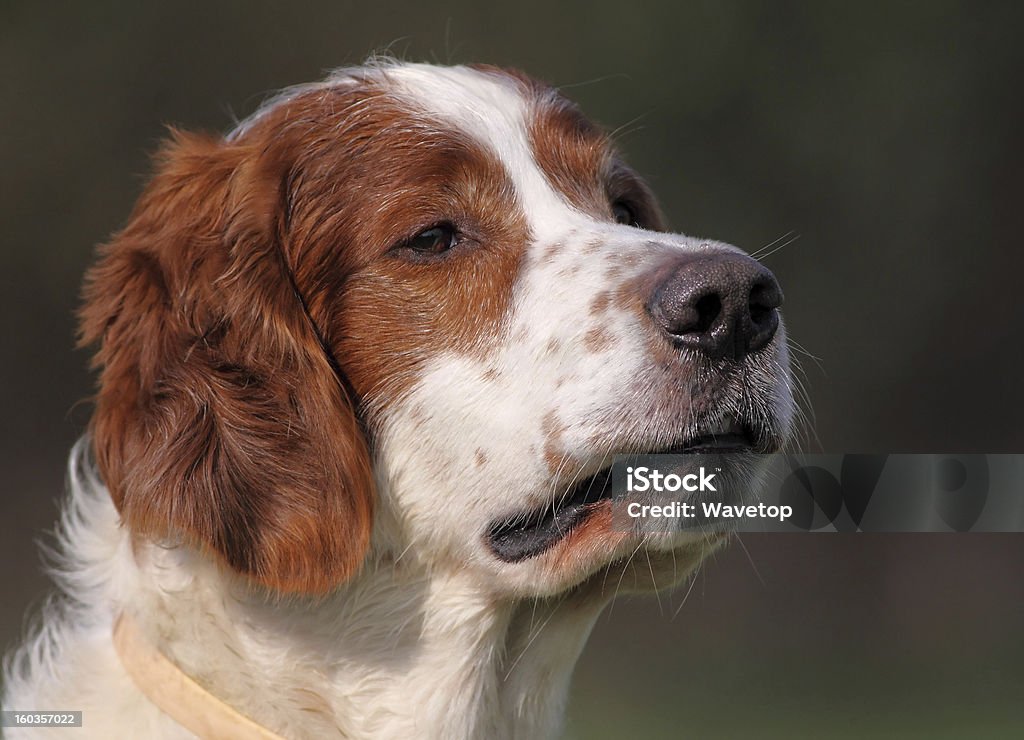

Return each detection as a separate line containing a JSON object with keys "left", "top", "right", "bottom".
{"left": 3, "top": 64, "right": 792, "bottom": 738}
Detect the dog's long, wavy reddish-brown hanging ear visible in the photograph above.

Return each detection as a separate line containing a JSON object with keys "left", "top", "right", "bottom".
{"left": 81, "top": 128, "right": 373, "bottom": 593}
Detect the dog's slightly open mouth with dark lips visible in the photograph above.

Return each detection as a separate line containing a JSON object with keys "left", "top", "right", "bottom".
{"left": 486, "top": 419, "right": 764, "bottom": 563}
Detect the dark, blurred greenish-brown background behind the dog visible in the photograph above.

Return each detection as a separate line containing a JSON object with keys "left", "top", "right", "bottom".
{"left": 0, "top": 0, "right": 1024, "bottom": 738}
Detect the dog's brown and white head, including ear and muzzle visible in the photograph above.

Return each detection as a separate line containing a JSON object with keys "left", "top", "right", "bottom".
{"left": 82, "top": 64, "right": 793, "bottom": 595}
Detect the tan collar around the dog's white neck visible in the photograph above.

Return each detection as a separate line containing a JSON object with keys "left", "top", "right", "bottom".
{"left": 114, "top": 614, "right": 284, "bottom": 740}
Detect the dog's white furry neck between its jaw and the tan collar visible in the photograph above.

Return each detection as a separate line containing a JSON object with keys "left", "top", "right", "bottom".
{"left": 126, "top": 548, "right": 607, "bottom": 738}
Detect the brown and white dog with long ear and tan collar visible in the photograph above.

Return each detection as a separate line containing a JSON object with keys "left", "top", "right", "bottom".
{"left": 3, "top": 62, "right": 793, "bottom": 738}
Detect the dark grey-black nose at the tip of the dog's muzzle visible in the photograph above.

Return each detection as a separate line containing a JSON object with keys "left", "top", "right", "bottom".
{"left": 648, "top": 252, "right": 782, "bottom": 361}
